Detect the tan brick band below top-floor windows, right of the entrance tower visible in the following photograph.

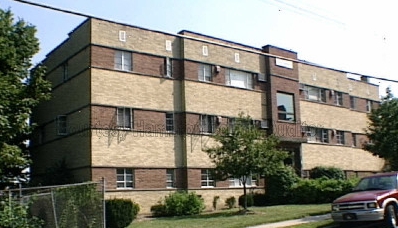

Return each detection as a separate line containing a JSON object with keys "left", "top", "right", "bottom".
{"left": 300, "top": 101, "right": 367, "bottom": 133}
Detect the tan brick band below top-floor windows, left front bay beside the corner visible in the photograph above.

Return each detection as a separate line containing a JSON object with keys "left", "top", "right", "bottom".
{"left": 91, "top": 69, "right": 181, "bottom": 111}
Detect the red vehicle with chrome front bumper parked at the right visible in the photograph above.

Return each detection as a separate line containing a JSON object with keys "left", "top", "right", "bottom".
{"left": 331, "top": 172, "right": 398, "bottom": 228}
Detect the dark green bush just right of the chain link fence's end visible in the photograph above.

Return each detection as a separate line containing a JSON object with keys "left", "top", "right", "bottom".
{"left": 105, "top": 199, "right": 140, "bottom": 228}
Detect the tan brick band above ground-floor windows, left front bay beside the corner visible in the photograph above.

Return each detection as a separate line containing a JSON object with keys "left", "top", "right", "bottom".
{"left": 91, "top": 130, "right": 182, "bottom": 168}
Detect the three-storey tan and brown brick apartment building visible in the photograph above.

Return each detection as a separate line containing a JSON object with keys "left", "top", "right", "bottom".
{"left": 31, "top": 18, "right": 383, "bottom": 213}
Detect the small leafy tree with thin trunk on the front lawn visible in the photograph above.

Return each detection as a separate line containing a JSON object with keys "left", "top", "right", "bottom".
{"left": 204, "top": 113, "right": 288, "bottom": 211}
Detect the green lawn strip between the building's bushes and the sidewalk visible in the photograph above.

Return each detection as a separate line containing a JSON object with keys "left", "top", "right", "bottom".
{"left": 129, "top": 204, "right": 330, "bottom": 228}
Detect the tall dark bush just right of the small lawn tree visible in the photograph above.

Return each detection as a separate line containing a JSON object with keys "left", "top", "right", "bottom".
{"left": 265, "top": 166, "right": 300, "bottom": 205}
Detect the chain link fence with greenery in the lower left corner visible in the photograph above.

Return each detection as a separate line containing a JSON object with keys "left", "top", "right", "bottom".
{"left": 0, "top": 181, "right": 105, "bottom": 228}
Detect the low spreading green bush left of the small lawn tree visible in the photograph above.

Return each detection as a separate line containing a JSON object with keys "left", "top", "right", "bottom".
{"left": 151, "top": 192, "right": 205, "bottom": 216}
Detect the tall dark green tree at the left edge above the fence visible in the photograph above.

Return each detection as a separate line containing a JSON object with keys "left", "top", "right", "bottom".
{"left": 0, "top": 9, "right": 50, "bottom": 183}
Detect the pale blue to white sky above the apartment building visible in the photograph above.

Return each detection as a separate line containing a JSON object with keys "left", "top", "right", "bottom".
{"left": 0, "top": 0, "right": 398, "bottom": 96}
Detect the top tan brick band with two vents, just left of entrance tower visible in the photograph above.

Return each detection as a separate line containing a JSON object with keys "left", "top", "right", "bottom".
{"left": 184, "top": 39, "right": 265, "bottom": 73}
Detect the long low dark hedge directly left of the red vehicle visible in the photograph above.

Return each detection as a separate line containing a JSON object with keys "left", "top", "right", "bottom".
{"left": 292, "top": 178, "right": 356, "bottom": 204}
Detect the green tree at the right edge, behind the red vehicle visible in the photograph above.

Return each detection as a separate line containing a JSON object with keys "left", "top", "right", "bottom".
{"left": 364, "top": 89, "right": 398, "bottom": 170}
